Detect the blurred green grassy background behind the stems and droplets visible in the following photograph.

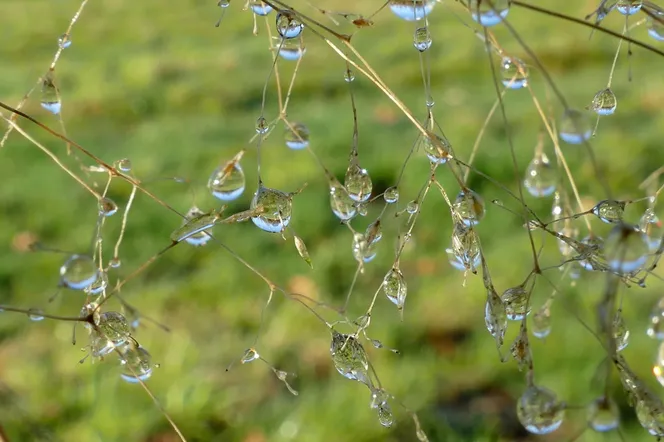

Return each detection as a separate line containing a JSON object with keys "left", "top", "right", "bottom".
{"left": 0, "top": 0, "right": 664, "bottom": 442}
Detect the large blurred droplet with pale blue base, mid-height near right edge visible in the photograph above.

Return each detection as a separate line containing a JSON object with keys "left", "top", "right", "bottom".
{"left": 604, "top": 223, "right": 649, "bottom": 273}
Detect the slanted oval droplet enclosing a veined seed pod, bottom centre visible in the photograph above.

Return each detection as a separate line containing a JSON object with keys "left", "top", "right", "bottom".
{"left": 330, "top": 330, "right": 371, "bottom": 386}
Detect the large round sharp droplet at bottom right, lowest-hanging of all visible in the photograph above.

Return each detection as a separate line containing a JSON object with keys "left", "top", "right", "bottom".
{"left": 516, "top": 385, "right": 565, "bottom": 434}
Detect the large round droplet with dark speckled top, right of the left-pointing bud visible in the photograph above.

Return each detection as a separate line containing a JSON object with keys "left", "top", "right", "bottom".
{"left": 250, "top": 185, "right": 293, "bottom": 233}
